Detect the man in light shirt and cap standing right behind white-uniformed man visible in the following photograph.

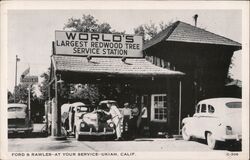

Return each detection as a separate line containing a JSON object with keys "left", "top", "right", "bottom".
{"left": 122, "top": 102, "right": 132, "bottom": 138}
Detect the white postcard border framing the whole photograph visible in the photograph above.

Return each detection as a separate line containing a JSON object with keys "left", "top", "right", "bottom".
{"left": 0, "top": 1, "right": 249, "bottom": 159}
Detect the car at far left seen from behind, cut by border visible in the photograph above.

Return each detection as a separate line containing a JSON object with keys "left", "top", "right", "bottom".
{"left": 8, "top": 103, "right": 33, "bottom": 134}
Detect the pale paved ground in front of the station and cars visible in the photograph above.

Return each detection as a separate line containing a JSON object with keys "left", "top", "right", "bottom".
{"left": 8, "top": 124, "right": 240, "bottom": 152}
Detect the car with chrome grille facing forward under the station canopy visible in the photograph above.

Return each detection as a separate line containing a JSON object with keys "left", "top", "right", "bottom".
{"left": 74, "top": 101, "right": 115, "bottom": 140}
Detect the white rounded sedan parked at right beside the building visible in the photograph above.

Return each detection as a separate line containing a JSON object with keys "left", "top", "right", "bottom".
{"left": 182, "top": 98, "right": 242, "bottom": 149}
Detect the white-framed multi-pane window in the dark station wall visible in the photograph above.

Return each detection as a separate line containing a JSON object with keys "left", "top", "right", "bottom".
{"left": 151, "top": 94, "right": 167, "bottom": 121}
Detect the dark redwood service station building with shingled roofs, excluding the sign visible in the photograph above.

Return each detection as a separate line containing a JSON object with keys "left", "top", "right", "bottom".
{"left": 50, "top": 21, "right": 241, "bottom": 137}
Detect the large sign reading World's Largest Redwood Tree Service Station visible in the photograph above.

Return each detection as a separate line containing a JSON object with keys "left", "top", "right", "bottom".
{"left": 55, "top": 31, "right": 143, "bottom": 57}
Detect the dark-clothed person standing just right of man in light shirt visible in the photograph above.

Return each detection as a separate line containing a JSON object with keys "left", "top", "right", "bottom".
{"left": 129, "top": 104, "right": 139, "bottom": 139}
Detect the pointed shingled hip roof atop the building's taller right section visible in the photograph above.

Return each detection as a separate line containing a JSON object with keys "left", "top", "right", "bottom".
{"left": 143, "top": 21, "right": 242, "bottom": 51}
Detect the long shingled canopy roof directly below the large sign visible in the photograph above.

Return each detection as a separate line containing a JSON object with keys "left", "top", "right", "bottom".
{"left": 51, "top": 55, "right": 184, "bottom": 81}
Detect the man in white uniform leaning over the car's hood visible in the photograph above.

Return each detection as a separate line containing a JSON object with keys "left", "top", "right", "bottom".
{"left": 104, "top": 102, "right": 122, "bottom": 140}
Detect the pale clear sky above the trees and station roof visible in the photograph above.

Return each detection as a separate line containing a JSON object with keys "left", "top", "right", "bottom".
{"left": 7, "top": 9, "right": 242, "bottom": 91}
